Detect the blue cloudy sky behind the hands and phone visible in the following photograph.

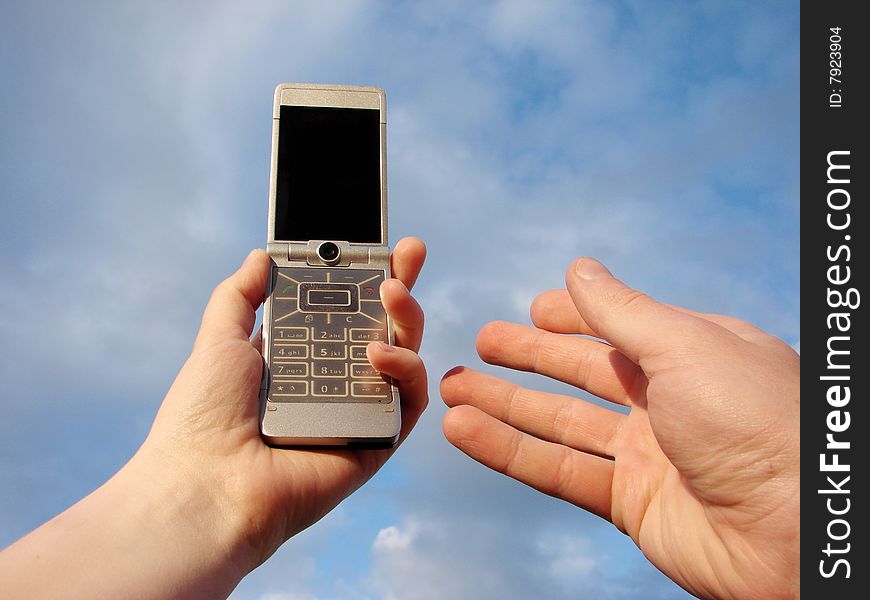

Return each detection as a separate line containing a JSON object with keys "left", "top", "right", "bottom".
{"left": 0, "top": 0, "right": 800, "bottom": 600}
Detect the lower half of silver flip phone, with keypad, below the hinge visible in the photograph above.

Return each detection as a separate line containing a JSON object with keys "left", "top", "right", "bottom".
{"left": 260, "top": 265, "right": 401, "bottom": 448}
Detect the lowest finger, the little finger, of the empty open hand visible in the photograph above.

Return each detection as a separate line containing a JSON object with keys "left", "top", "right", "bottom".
{"left": 443, "top": 405, "right": 614, "bottom": 520}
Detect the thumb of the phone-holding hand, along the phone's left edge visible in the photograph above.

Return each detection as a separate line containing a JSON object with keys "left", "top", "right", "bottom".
{"left": 194, "top": 250, "right": 269, "bottom": 347}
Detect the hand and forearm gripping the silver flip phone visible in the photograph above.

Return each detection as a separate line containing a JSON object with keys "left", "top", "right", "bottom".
{"left": 0, "top": 238, "right": 427, "bottom": 598}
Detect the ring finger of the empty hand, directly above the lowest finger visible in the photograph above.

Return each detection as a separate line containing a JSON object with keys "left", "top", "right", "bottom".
{"left": 441, "top": 367, "right": 626, "bottom": 456}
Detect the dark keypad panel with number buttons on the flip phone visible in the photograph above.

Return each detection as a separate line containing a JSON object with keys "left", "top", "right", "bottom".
{"left": 268, "top": 267, "right": 393, "bottom": 404}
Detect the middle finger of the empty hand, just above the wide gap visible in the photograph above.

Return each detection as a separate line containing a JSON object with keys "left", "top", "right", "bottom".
{"left": 477, "top": 321, "right": 646, "bottom": 405}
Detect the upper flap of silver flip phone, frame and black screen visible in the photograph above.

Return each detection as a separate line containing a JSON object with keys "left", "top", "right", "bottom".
{"left": 267, "top": 83, "right": 387, "bottom": 246}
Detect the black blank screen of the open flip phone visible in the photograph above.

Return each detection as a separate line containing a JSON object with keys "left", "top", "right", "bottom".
{"left": 274, "top": 106, "right": 382, "bottom": 244}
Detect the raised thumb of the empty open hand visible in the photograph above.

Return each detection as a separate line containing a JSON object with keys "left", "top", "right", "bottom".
{"left": 565, "top": 257, "right": 708, "bottom": 367}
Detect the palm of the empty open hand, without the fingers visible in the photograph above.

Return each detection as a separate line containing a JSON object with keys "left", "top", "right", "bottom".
{"left": 613, "top": 338, "right": 799, "bottom": 598}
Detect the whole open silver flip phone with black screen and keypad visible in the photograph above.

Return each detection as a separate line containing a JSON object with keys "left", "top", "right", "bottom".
{"left": 260, "top": 83, "right": 401, "bottom": 447}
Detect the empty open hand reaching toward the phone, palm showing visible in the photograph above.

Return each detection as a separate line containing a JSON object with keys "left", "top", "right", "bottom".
{"left": 441, "top": 266, "right": 799, "bottom": 598}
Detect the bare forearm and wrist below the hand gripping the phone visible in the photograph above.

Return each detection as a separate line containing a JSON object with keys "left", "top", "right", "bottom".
{"left": 0, "top": 440, "right": 251, "bottom": 599}
